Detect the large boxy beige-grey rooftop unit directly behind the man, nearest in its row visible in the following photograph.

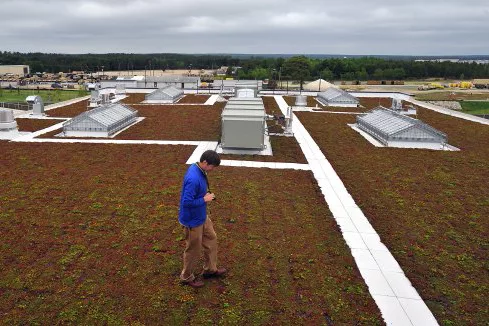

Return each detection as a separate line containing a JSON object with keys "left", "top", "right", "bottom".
{"left": 221, "top": 109, "right": 265, "bottom": 149}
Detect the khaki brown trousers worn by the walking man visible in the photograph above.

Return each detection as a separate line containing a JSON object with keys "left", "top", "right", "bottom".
{"left": 180, "top": 217, "right": 217, "bottom": 282}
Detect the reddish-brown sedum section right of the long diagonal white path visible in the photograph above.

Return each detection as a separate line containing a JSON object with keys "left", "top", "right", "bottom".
{"left": 297, "top": 109, "right": 489, "bottom": 325}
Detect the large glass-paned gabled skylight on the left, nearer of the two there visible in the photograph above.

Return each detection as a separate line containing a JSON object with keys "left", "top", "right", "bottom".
{"left": 63, "top": 103, "right": 138, "bottom": 137}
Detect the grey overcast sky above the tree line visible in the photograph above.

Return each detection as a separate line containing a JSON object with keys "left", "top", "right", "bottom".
{"left": 0, "top": 0, "right": 489, "bottom": 55}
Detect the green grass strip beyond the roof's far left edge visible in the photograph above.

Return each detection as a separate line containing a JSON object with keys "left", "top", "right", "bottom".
{"left": 0, "top": 89, "right": 90, "bottom": 104}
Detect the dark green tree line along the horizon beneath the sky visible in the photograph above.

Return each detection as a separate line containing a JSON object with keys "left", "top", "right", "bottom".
{"left": 0, "top": 51, "right": 489, "bottom": 80}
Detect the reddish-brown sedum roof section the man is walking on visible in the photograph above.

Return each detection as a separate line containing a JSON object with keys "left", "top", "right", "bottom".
{"left": 0, "top": 142, "right": 382, "bottom": 325}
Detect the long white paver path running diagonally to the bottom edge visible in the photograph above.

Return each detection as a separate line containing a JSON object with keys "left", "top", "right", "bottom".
{"left": 274, "top": 95, "right": 438, "bottom": 326}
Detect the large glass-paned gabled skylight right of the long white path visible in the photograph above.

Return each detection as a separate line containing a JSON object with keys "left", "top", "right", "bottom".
{"left": 357, "top": 106, "right": 447, "bottom": 149}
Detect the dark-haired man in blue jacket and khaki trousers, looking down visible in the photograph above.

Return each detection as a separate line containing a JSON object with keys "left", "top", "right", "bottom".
{"left": 178, "top": 150, "right": 226, "bottom": 288}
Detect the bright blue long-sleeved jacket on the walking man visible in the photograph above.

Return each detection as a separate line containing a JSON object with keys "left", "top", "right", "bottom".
{"left": 178, "top": 164, "right": 207, "bottom": 228}
